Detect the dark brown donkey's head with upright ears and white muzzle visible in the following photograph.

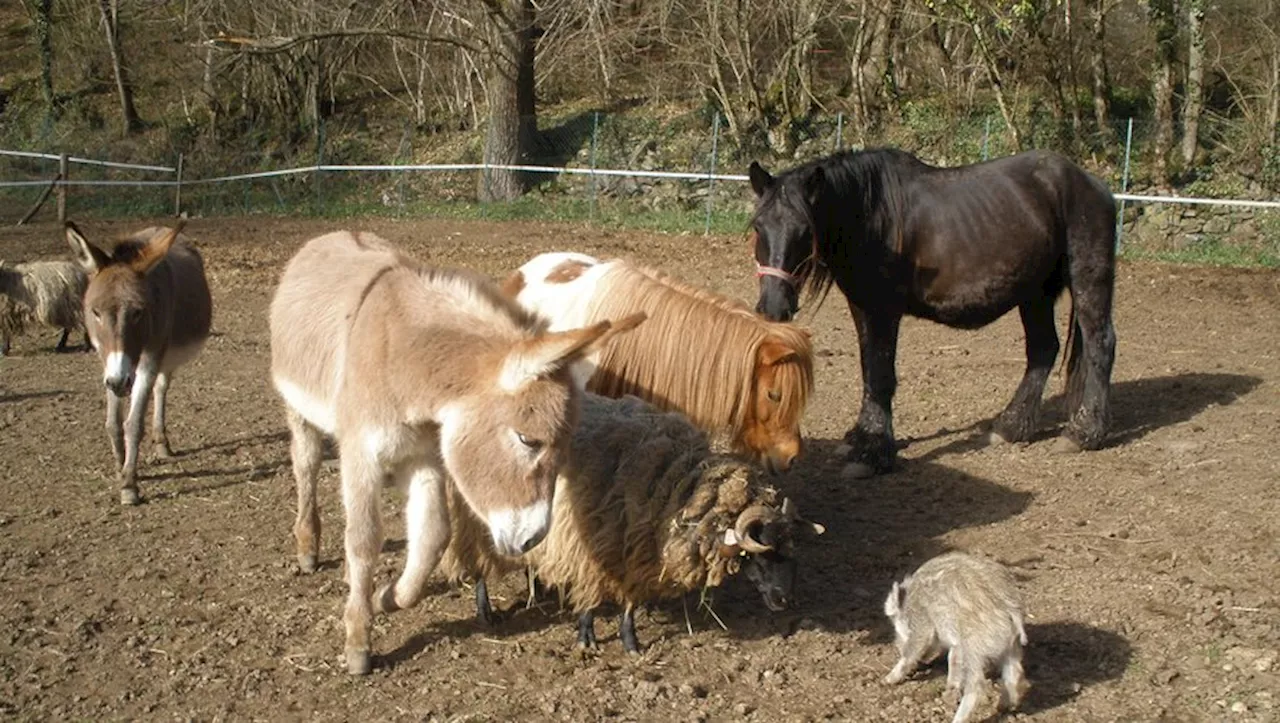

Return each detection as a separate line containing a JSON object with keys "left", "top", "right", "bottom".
{"left": 65, "top": 220, "right": 186, "bottom": 397}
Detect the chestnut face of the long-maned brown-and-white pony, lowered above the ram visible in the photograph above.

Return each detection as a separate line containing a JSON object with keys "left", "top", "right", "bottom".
{"left": 741, "top": 326, "right": 813, "bottom": 473}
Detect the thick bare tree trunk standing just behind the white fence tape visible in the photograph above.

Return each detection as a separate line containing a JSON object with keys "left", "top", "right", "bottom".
{"left": 477, "top": 0, "right": 538, "bottom": 201}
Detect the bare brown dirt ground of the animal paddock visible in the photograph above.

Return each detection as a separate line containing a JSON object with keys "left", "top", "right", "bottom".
{"left": 0, "top": 218, "right": 1280, "bottom": 722}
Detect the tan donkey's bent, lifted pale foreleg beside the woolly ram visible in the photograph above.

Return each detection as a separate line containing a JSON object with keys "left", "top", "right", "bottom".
{"left": 374, "top": 463, "right": 449, "bottom": 613}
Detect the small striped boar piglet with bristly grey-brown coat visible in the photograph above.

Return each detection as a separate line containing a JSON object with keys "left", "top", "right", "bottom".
{"left": 884, "top": 552, "right": 1028, "bottom": 723}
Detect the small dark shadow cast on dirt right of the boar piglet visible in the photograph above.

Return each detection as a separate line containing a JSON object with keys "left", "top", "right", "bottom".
{"left": 1019, "top": 622, "right": 1133, "bottom": 714}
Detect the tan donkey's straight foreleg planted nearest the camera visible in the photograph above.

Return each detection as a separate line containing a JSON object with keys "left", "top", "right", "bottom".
{"left": 338, "top": 444, "right": 383, "bottom": 676}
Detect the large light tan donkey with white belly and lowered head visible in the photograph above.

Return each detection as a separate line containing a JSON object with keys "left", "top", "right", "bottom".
{"left": 271, "top": 232, "right": 644, "bottom": 674}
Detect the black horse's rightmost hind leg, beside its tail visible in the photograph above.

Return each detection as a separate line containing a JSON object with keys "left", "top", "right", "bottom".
{"left": 1064, "top": 248, "right": 1116, "bottom": 449}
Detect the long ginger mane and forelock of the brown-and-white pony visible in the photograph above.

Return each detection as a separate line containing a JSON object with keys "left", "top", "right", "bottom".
{"left": 588, "top": 261, "right": 813, "bottom": 447}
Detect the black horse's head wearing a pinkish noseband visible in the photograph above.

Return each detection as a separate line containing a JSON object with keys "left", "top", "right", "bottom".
{"left": 749, "top": 161, "right": 824, "bottom": 321}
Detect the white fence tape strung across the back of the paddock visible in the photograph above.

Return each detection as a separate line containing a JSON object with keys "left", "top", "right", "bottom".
{"left": 0, "top": 150, "right": 1280, "bottom": 209}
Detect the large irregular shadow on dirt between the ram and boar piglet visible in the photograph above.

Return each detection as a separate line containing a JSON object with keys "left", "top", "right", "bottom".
{"left": 714, "top": 439, "right": 1034, "bottom": 642}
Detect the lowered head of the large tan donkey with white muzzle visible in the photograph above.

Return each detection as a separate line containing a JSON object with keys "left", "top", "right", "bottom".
{"left": 440, "top": 314, "right": 644, "bottom": 555}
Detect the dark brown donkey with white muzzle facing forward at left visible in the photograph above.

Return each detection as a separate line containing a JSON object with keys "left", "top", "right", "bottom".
{"left": 67, "top": 221, "right": 212, "bottom": 504}
